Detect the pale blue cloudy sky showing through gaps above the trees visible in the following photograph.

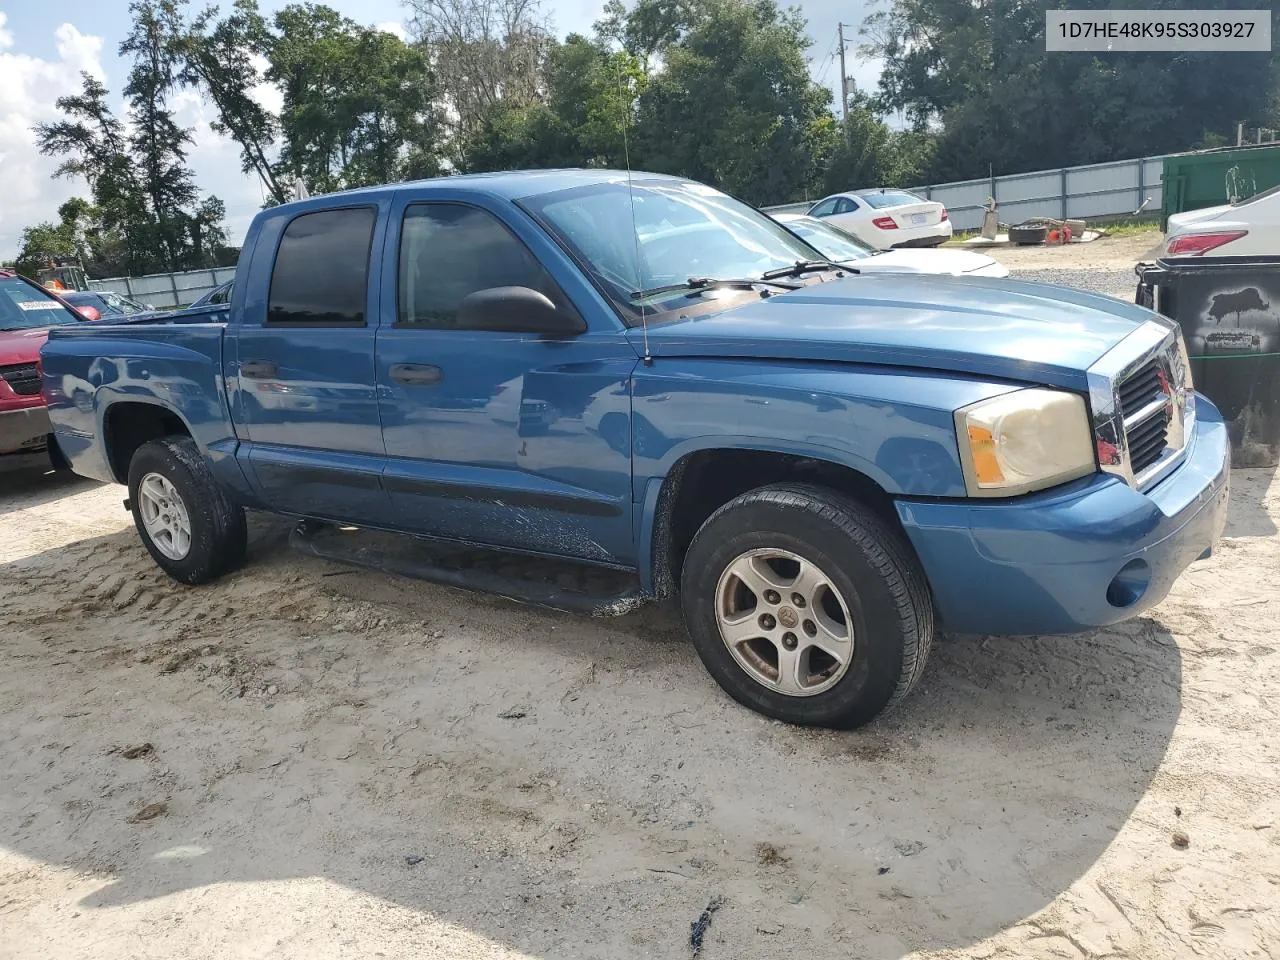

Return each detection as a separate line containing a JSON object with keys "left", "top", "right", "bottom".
{"left": 0, "top": 0, "right": 879, "bottom": 260}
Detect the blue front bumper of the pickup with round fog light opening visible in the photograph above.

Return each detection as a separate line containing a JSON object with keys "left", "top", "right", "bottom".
{"left": 897, "top": 396, "right": 1230, "bottom": 634}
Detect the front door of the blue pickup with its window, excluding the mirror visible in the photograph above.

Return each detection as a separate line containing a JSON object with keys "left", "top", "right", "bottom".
{"left": 376, "top": 202, "right": 637, "bottom": 563}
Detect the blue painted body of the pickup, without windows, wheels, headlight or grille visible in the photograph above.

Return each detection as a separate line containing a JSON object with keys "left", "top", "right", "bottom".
{"left": 41, "top": 170, "right": 1228, "bottom": 632}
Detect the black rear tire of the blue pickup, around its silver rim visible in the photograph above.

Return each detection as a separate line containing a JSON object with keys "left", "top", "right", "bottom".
{"left": 129, "top": 436, "right": 248, "bottom": 584}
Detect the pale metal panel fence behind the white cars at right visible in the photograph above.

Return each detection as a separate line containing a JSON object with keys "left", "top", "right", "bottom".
{"left": 764, "top": 156, "right": 1165, "bottom": 230}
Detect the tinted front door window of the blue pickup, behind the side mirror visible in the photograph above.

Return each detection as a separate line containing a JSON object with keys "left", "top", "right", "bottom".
{"left": 399, "top": 204, "right": 564, "bottom": 328}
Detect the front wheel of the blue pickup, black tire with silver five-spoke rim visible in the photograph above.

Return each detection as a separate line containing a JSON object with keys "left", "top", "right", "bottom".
{"left": 681, "top": 484, "right": 933, "bottom": 728}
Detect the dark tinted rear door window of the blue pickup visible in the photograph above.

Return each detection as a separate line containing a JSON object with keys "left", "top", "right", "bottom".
{"left": 266, "top": 207, "right": 378, "bottom": 326}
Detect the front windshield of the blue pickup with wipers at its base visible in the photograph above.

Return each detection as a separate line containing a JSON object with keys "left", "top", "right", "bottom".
{"left": 521, "top": 179, "right": 822, "bottom": 323}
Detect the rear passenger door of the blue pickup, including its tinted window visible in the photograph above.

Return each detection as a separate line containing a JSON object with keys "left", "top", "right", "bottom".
{"left": 229, "top": 197, "right": 390, "bottom": 522}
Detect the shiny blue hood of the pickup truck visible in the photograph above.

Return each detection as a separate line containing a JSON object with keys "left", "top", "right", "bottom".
{"left": 630, "top": 274, "right": 1157, "bottom": 390}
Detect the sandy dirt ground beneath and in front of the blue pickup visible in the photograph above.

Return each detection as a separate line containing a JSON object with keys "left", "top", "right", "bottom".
{"left": 0, "top": 442, "right": 1280, "bottom": 960}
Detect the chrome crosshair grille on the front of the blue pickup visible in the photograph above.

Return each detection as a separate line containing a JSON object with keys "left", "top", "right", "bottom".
{"left": 1089, "top": 320, "right": 1196, "bottom": 489}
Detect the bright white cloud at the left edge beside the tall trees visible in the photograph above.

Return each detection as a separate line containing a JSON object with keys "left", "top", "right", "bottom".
{"left": 0, "top": 13, "right": 104, "bottom": 259}
